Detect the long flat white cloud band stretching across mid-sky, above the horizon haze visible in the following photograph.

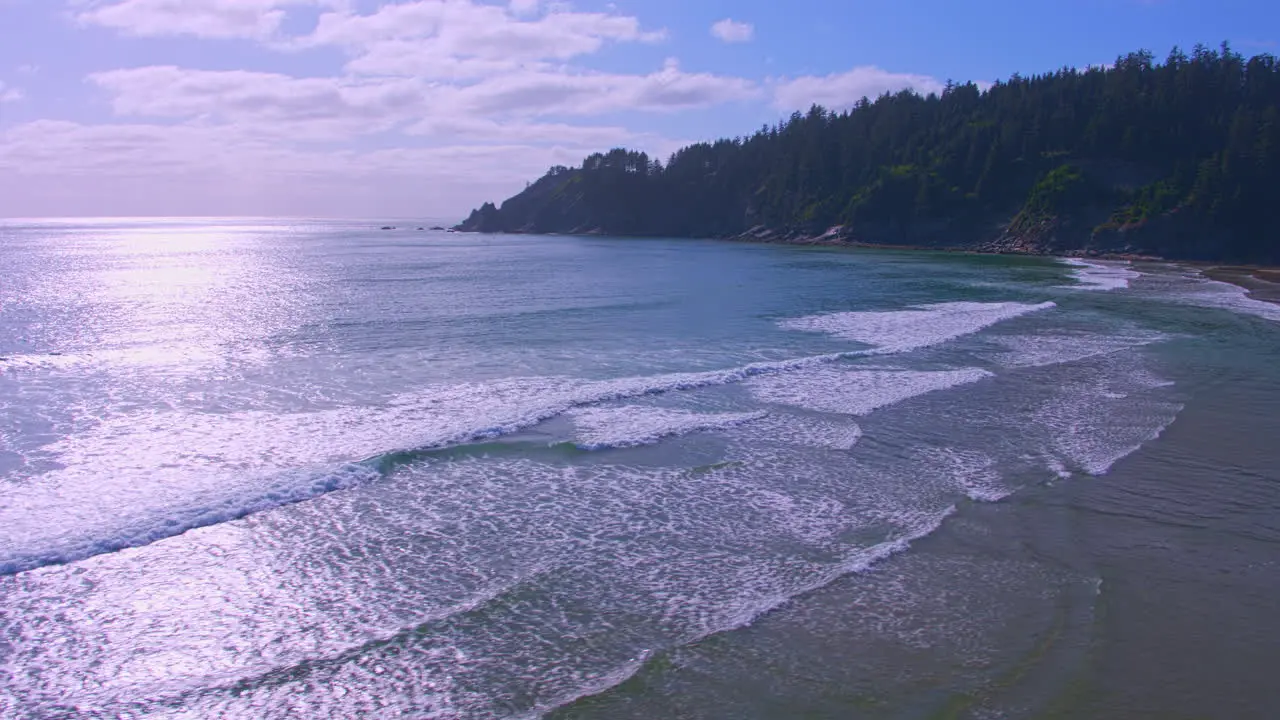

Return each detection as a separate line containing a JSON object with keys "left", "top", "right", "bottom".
{"left": 90, "top": 60, "right": 760, "bottom": 134}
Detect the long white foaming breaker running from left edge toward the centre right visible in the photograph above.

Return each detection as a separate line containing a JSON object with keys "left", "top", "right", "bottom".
{"left": 0, "top": 352, "right": 890, "bottom": 574}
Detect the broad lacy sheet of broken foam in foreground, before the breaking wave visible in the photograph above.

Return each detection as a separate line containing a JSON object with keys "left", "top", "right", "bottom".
{"left": 6, "top": 445, "right": 952, "bottom": 717}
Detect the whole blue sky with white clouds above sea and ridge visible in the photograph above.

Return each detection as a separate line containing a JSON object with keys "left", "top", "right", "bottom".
{"left": 0, "top": 0, "right": 1280, "bottom": 219}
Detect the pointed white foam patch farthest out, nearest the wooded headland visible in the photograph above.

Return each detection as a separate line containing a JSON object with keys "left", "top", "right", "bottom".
{"left": 782, "top": 302, "right": 1055, "bottom": 354}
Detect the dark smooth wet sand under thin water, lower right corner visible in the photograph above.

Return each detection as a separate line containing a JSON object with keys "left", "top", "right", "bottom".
{"left": 552, "top": 345, "right": 1280, "bottom": 720}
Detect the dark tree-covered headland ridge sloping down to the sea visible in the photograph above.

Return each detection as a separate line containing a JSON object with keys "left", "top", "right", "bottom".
{"left": 460, "top": 44, "right": 1280, "bottom": 263}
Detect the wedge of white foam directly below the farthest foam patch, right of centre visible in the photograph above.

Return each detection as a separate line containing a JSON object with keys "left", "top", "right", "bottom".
{"left": 749, "top": 368, "right": 992, "bottom": 415}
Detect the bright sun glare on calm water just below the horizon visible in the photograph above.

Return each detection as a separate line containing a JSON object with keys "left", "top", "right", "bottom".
{"left": 26, "top": 220, "right": 312, "bottom": 370}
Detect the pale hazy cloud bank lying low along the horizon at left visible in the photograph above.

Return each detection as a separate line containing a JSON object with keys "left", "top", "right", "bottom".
{"left": 0, "top": 120, "right": 669, "bottom": 219}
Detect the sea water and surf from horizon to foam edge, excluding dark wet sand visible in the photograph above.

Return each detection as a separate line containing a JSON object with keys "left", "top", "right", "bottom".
{"left": 0, "top": 220, "right": 1280, "bottom": 717}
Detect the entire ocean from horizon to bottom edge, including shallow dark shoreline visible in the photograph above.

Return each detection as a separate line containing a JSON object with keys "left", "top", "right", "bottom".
{"left": 0, "top": 219, "right": 1280, "bottom": 719}
